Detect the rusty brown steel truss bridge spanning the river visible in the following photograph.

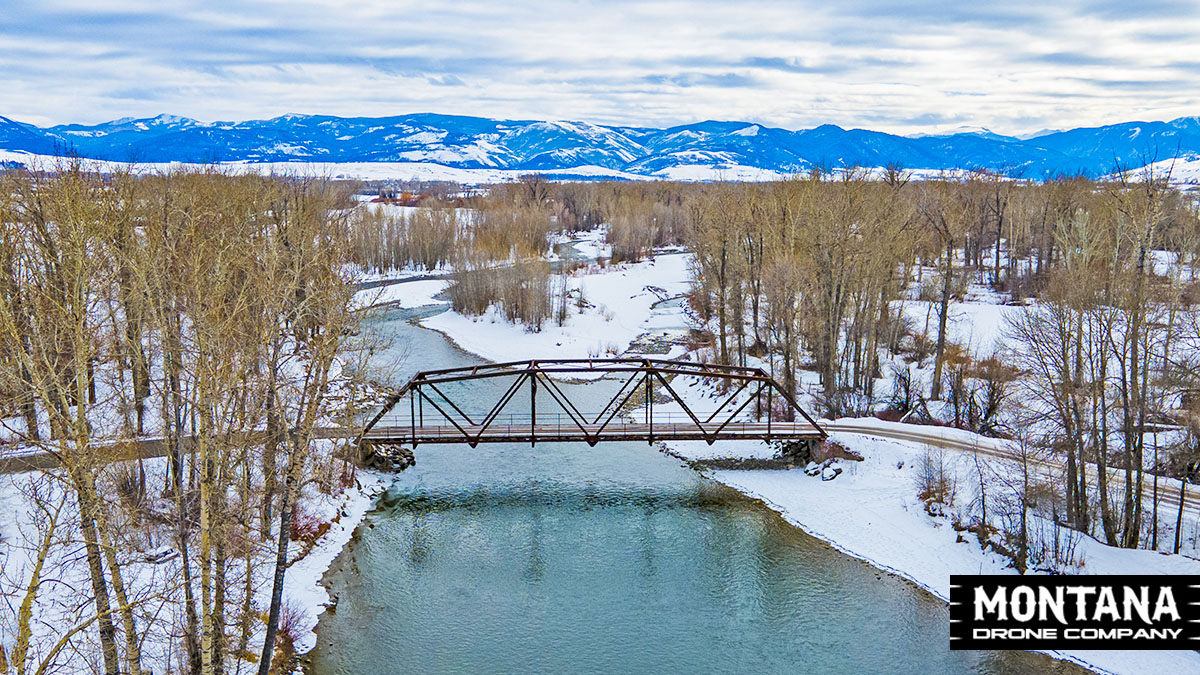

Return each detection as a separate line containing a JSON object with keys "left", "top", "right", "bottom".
{"left": 359, "top": 358, "right": 826, "bottom": 447}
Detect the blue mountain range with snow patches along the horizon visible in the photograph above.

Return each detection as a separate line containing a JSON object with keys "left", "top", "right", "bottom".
{"left": 0, "top": 113, "right": 1200, "bottom": 179}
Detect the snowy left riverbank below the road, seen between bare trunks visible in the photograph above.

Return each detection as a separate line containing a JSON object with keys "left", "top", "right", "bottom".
{"left": 0, "top": 449, "right": 394, "bottom": 674}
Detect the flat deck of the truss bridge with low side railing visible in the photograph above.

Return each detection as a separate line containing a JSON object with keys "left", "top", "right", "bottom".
{"left": 364, "top": 420, "right": 824, "bottom": 446}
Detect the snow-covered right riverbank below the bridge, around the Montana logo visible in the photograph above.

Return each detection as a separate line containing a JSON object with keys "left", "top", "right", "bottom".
{"left": 670, "top": 432, "right": 1200, "bottom": 675}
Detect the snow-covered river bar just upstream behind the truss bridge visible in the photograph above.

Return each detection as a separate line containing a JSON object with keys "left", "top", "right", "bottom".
{"left": 421, "top": 255, "right": 690, "bottom": 362}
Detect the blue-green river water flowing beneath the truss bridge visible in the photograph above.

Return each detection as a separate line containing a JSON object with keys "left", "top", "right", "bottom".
{"left": 308, "top": 302, "right": 1079, "bottom": 675}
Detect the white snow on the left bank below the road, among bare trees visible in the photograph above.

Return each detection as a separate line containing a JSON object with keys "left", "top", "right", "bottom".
{"left": 0, "top": 458, "right": 392, "bottom": 674}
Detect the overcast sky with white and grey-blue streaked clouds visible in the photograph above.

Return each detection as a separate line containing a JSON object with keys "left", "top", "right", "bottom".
{"left": 0, "top": 0, "right": 1200, "bottom": 133}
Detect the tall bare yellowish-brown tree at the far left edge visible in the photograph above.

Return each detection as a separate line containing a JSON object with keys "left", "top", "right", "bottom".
{"left": 0, "top": 162, "right": 142, "bottom": 675}
